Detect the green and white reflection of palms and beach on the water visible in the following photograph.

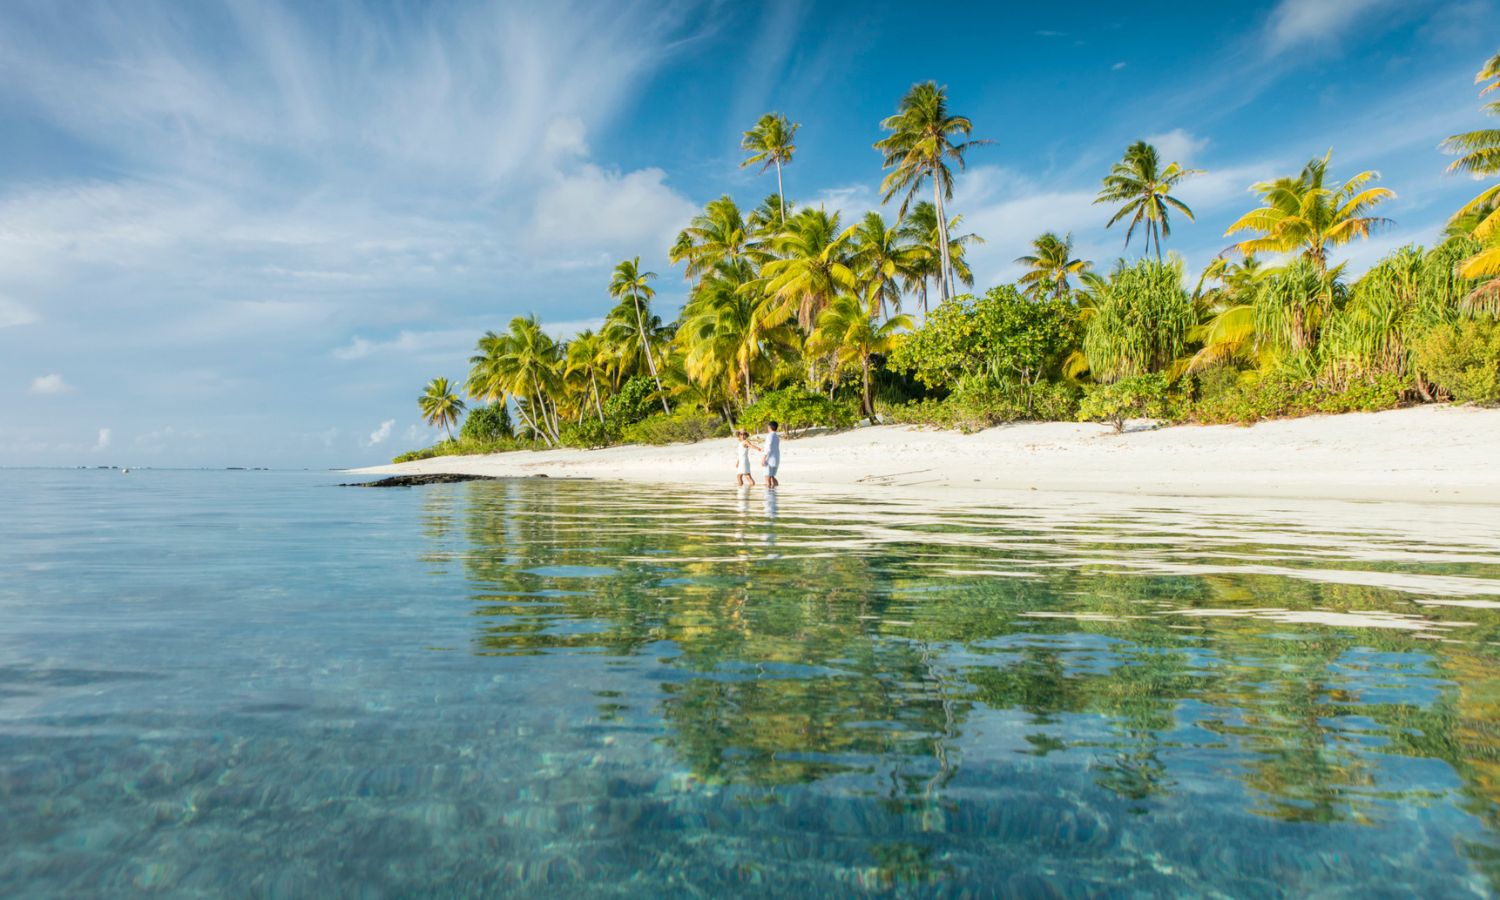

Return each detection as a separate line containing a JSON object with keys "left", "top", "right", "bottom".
{"left": 444, "top": 483, "right": 1500, "bottom": 888}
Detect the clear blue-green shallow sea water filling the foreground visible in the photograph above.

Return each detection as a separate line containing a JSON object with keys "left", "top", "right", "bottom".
{"left": 0, "top": 471, "right": 1500, "bottom": 897}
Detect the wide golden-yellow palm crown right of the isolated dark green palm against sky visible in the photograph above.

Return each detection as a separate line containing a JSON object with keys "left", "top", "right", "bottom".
{"left": 1224, "top": 150, "right": 1395, "bottom": 272}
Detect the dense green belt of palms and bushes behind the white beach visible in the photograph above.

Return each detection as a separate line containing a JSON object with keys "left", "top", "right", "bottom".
{"left": 396, "top": 56, "right": 1500, "bottom": 456}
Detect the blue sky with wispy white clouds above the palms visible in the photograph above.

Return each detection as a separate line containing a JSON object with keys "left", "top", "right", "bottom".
{"left": 0, "top": 0, "right": 1500, "bottom": 467}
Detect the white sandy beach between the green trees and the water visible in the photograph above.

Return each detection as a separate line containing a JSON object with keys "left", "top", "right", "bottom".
{"left": 350, "top": 407, "right": 1500, "bottom": 506}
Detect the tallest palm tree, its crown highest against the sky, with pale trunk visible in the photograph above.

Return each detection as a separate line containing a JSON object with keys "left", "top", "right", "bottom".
{"left": 875, "top": 81, "right": 989, "bottom": 300}
